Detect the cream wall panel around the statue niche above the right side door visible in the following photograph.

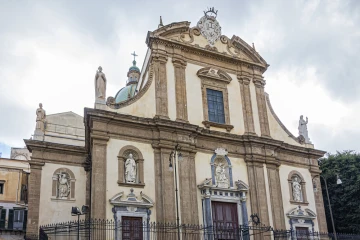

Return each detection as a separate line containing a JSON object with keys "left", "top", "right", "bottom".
{"left": 279, "top": 164, "right": 319, "bottom": 231}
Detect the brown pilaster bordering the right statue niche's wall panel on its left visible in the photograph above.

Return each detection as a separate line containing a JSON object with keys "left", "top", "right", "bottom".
{"left": 266, "top": 164, "right": 286, "bottom": 230}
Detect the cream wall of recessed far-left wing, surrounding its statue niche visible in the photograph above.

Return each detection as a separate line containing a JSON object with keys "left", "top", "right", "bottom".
{"left": 39, "top": 163, "right": 86, "bottom": 225}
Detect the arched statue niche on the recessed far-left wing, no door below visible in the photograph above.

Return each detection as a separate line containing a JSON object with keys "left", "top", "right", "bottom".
{"left": 52, "top": 168, "right": 75, "bottom": 200}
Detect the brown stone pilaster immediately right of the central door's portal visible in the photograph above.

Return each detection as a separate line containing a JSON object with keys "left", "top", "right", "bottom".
{"left": 245, "top": 157, "right": 271, "bottom": 240}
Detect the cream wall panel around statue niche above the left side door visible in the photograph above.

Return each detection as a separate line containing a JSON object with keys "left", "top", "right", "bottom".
{"left": 106, "top": 138, "right": 156, "bottom": 221}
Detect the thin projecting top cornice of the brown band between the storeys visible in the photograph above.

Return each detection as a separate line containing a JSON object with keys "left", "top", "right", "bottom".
{"left": 85, "top": 108, "right": 325, "bottom": 161}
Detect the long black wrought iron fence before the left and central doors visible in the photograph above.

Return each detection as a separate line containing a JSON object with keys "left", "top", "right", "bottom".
{"left": 39, "top": 219, "right": 272, "bottom": 240}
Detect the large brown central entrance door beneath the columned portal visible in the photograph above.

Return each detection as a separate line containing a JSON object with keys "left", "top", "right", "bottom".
{"left": 211, "top": 202, "right": 239, "bottom": 239}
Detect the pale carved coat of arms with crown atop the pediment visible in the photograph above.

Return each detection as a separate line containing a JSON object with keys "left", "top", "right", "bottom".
{"left": 197, "top": 8, "right": 221, "bottom": 46}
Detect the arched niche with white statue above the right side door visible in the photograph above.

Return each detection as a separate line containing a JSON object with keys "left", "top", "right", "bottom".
{"left": 288, "top": 171, "right": 308, "bottom": 205}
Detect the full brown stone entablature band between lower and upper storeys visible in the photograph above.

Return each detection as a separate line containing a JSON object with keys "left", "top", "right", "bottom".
{"left": 84, "top": 108, "right": 325, "bottom": 166}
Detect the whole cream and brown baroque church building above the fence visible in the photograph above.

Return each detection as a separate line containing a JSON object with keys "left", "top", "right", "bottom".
{"left": 25, "top": 9, "right": 327, "bottom": 239}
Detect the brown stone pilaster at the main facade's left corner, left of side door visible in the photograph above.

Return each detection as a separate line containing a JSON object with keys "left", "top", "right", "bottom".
{"left": 91, "top": 135, "right": 109, "bottom": 219}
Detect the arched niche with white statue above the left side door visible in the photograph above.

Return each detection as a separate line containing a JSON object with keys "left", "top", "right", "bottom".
{"left": 118, "top": 145, "right": 145, "bottom": 187}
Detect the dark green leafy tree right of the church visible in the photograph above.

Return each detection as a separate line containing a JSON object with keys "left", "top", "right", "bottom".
{"left": 319, "top": 151, "right": 360, "bottom": 234}
